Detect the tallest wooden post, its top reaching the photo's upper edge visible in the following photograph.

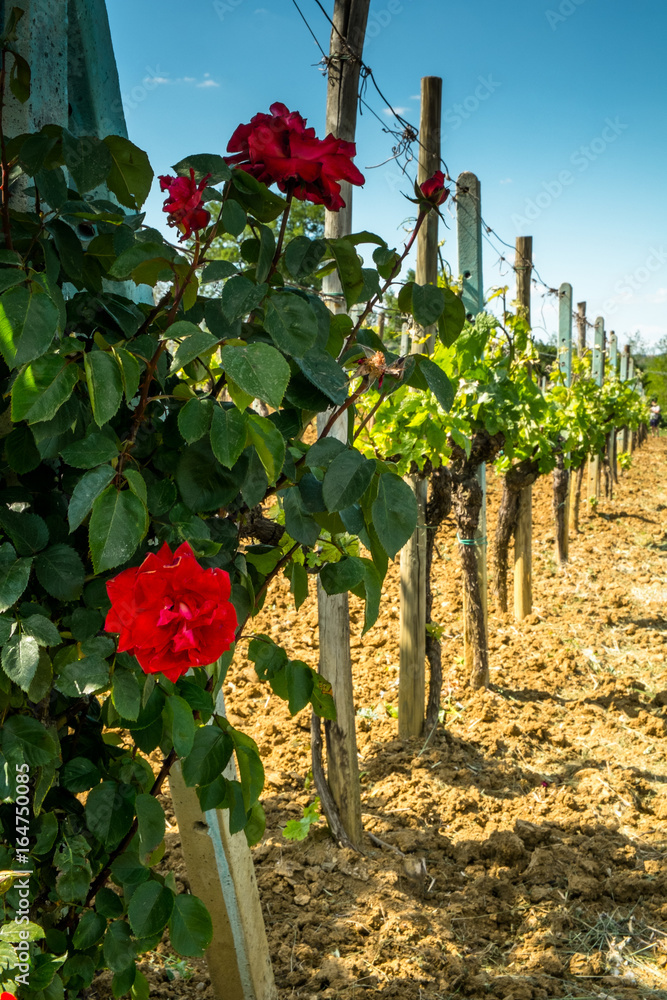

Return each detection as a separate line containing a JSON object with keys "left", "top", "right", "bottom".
{"left": 317, "top": 0, "right": 370, "bottom": 846}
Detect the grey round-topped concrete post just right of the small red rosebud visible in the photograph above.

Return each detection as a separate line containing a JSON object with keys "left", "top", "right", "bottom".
{"left": 456, "top": 171, "right": 488, "bottom": 675}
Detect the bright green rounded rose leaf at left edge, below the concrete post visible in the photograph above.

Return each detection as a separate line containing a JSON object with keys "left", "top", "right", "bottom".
{"left": 0, "top": 284, "right": 59, "bottom": 368}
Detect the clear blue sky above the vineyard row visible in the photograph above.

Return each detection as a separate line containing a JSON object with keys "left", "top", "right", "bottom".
{"left": 107, "top": 0, "right": 667, "bottom": 344}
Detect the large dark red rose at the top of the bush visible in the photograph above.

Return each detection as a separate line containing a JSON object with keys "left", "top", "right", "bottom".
{"left": 225, "top": 103, "right": 364, "bottom": 212}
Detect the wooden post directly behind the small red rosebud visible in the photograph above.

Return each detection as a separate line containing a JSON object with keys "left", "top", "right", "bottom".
{"left": 398, "top": 76, "right": 442, "bottom": 739}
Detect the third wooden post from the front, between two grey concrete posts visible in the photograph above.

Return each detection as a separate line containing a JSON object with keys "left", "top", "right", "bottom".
{"left": 514, "top": 236, "right": 533, "bottom": 621}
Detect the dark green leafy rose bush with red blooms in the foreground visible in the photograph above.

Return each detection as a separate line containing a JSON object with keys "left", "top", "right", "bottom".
{"left": 0, "top": 17, "right": 462, "bottom": 1000}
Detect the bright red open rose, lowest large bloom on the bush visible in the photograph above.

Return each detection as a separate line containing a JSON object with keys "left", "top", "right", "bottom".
{"left": 104, "top": 542, "right": 237, "bottom": 681}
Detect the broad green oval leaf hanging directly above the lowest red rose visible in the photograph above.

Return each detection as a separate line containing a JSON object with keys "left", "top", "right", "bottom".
{"left": 89, "top": 486, "right": 148, "bottom": 573}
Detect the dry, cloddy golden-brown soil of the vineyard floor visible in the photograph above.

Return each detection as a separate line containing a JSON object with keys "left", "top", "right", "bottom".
{"left": 91, "top": 439, "right": 667, "bottom": 1000}
